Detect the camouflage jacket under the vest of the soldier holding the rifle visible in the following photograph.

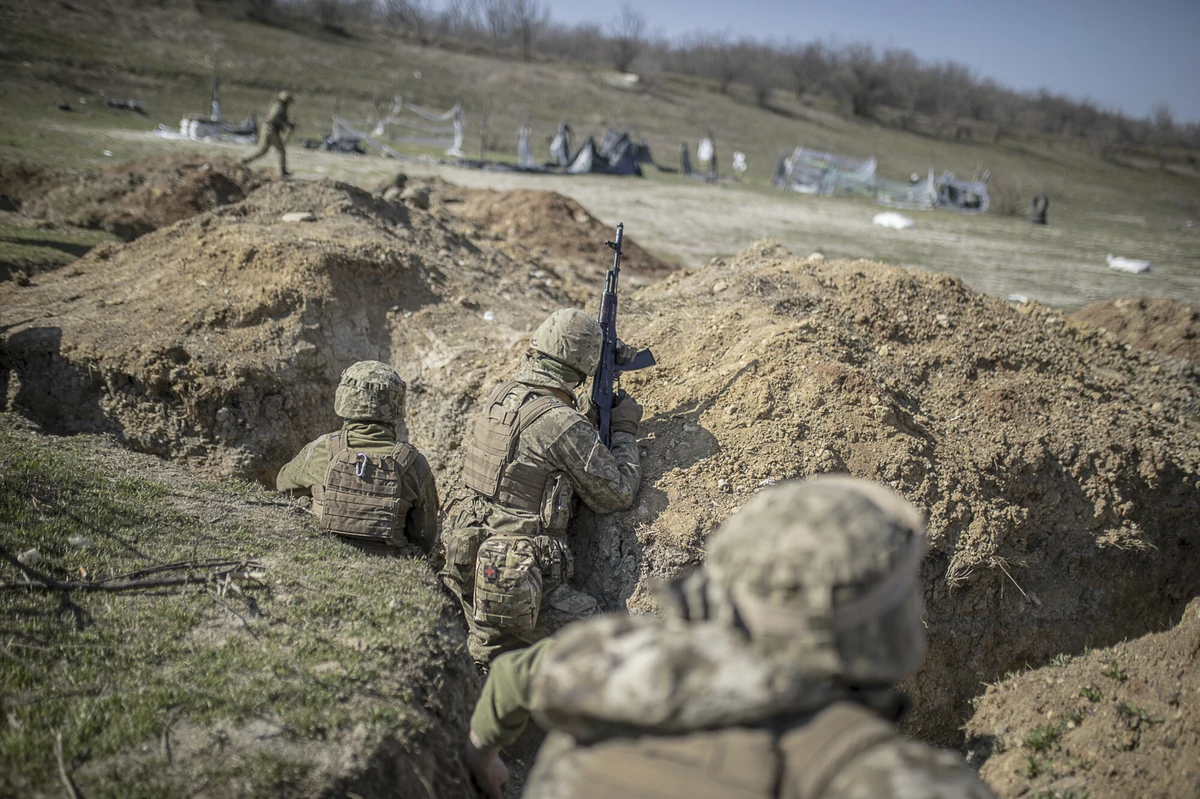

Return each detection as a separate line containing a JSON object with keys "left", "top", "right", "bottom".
{"left": 451, "top": 358, "right": 642, "bottom": 536}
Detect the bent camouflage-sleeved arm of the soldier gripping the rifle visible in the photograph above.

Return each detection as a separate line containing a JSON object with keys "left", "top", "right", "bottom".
{"left": 548, "top": 416, "right": 642, "bottom": 513}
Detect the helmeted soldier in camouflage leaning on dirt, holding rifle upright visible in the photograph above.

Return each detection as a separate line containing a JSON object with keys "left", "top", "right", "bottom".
{"left": 442, "top": 308, "right": 642, "bottom": 665}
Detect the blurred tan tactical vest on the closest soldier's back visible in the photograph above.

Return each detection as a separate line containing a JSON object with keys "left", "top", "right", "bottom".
{"left": 535, "top": 702, "right": 901, "bottom": 799}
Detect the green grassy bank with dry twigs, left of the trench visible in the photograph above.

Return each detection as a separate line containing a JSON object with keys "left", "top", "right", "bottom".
{"left": 0, "top": 415, "right": 468, "bottom": 797}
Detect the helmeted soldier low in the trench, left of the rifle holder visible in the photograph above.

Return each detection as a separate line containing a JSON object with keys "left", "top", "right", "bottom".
{"left": 276, "top": 361, "right": 438, "bottom": 554}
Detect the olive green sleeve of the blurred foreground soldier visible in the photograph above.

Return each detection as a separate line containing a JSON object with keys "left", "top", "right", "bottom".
{"left": 470, "top": 638, "right": 554, "bottom": 746}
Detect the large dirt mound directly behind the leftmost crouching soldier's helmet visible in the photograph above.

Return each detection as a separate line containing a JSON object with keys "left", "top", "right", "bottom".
{"left": 0, "top": 181, "right": 571, "bottom": 480}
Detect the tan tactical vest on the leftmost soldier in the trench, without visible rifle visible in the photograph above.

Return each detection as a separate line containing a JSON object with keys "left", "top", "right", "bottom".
{"left": 313, "top": 431, "right": 416, "bottom": 547}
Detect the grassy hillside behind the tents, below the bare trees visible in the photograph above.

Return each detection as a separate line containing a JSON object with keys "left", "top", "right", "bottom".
{"left": 0, "top": 1, "right": 1200, "bottom": 226}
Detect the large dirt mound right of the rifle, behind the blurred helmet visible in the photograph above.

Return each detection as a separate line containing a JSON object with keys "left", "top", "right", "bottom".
{"left": 576, "top": 244, "right": 1200, "bottom": 743}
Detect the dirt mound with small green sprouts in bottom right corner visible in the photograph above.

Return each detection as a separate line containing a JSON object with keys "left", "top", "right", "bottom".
{"left": 967, "top": 600, "right": 1200, "bottom": 799}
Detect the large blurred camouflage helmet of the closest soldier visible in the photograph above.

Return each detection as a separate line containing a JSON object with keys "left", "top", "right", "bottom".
{"left": 706, "top": 475, "right": 925, "bottom": 685}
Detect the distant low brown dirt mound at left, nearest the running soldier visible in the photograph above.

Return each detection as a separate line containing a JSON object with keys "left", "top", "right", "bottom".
{"left": 0, "top": 154, "right": 263, "bottom": 241}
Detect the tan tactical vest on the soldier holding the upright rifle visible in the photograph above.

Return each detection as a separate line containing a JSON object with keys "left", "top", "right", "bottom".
{"left": 462, "top": 380, "right": 566, "bottom": 513}
